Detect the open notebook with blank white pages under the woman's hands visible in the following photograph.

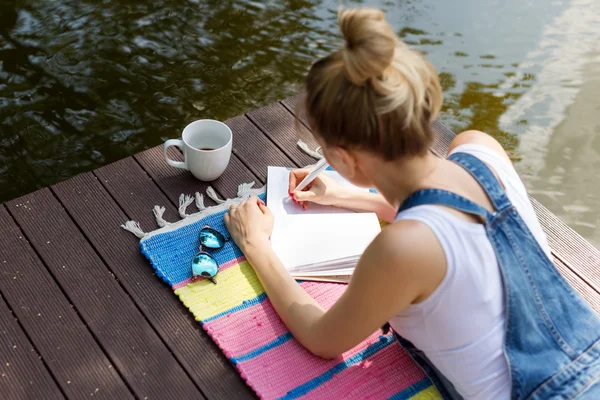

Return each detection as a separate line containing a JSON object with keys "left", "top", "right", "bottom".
{"left": 267, "top": 167, "right": 381, "bottom": 282}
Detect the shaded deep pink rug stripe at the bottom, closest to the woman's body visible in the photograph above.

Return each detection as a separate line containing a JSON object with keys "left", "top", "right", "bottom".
{"left": 304, "top": 343, "right": 425, "bottom": 399}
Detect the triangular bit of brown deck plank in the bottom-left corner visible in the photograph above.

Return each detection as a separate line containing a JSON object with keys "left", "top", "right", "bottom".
{"left": 0, "top": 290, "right": 64, "bottom": 399}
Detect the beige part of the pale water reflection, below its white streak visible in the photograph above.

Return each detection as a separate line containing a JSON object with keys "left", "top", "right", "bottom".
{"left": 519, "top": 58, "right": 600, "bottom": 247}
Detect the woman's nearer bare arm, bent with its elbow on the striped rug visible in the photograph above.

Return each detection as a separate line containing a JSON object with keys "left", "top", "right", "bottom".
{"left": 225, "top": 198, "right": 434, "bottom": 358}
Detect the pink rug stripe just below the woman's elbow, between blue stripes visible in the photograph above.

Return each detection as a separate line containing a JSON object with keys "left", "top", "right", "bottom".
{"left": 237, "top": 332, "right": 380, "bottom": 398}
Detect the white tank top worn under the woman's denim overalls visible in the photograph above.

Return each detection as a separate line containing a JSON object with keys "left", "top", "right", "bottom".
{"left": 390, "top": 144, "right": 550, "bottom": 400}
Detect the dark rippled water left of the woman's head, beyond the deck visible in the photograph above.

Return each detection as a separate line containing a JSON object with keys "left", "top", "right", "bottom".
{"left": 0, "top": 0, "right": 338, "bottom": 200}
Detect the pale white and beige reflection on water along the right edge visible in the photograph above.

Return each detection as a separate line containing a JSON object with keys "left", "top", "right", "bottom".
{"left": 499, "top": 0, "right": 600, "bottom": 247}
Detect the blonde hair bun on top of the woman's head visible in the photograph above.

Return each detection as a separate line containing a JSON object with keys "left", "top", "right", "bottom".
{"left": 338, "top": 8, "right": 396, "bottom": 85}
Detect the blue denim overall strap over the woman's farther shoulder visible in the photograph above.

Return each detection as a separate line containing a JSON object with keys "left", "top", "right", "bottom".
{"left": 448, "top": 153, "right": 511, "bottom": 211}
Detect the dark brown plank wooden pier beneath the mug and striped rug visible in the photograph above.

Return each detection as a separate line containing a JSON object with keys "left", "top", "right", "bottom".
{"left": 0, "top": 98, "right": 600, "bottom": 399}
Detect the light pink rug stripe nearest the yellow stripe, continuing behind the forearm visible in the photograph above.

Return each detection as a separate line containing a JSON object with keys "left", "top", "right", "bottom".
{"left": 204, "top": 282, "right": 345, "bottom": 358}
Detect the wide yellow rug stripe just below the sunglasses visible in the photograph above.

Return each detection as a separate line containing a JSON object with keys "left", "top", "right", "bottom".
{"left": 175, "top": 261, "right": 264, "bottom": 321}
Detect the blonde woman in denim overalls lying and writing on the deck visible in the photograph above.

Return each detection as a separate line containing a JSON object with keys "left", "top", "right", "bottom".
{"left": 225, "top": 9, "right": 600, "bottom": 399}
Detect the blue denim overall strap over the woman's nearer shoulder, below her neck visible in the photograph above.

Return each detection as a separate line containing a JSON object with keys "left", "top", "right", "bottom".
{"left": 398, "top": 189, "right": 492, "bottom": 221}
